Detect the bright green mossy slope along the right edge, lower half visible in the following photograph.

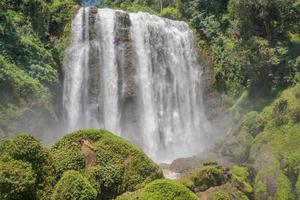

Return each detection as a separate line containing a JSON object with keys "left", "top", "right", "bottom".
{"left": 249, "top": 85, "right": 300, "bottom": 200}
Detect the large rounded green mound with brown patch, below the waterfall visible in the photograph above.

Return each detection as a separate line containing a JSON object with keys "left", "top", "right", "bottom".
{"left": 52, "top": 129, "right": 162, "bottom": 199}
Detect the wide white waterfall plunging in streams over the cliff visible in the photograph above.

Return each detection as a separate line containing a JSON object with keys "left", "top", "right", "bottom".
{"left": 63, "top": 8, "right": 210, "bottom": 161}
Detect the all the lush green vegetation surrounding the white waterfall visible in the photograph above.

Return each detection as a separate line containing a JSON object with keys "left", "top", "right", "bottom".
{"left": 0, "top": 0, "right": 300, "bottom": 200}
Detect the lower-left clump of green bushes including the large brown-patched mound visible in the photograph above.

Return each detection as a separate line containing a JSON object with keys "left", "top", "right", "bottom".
{"left": 0, "top": 129, "right": 164, "bottom": 200}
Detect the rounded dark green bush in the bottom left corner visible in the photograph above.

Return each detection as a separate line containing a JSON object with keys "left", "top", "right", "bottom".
{"left": 0, "top": 158, "right": 36, "bottom": 200}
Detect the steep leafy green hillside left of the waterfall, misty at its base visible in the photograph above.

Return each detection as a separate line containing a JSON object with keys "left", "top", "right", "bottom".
{"left": 0, "top": 0, "right": 78, "bottom": 136}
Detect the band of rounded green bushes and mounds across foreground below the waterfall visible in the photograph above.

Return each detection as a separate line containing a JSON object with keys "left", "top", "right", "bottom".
{"left": 0, "top": 129, "right": 253, "bottom": 200}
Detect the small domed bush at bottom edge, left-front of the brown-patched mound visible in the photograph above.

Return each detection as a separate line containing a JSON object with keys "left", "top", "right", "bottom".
{"left": 52, "top": 171, "right": 97, "bottom": 200}
